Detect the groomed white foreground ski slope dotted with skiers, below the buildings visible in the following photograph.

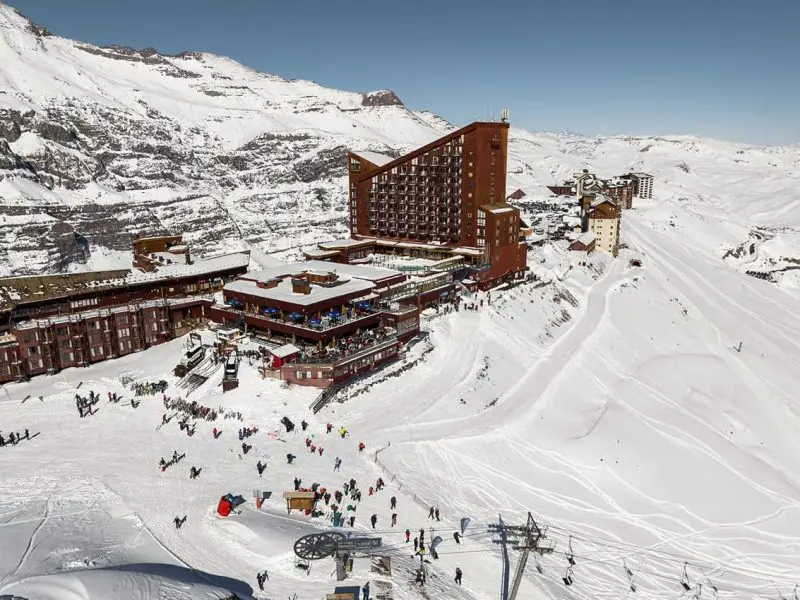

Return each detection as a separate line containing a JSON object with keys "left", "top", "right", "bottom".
{"left": 0, "top": 193, "right": 800, "bottom": 599}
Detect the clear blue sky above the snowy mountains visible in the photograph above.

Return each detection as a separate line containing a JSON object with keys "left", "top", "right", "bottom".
{"left": 6, "top": 0, "right": 800, "bottom": 144}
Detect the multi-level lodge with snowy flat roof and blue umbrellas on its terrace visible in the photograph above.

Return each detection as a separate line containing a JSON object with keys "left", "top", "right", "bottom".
{"left": 209, "top": 260, "right": 456, "bottom": 388}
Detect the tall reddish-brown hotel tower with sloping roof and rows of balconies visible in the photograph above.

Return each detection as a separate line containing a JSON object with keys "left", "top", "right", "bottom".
{"left": 349, "top": 122, "right": 526, "bottom": 285}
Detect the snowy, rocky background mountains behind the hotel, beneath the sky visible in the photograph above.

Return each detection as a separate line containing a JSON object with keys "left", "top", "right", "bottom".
{"left": 0, "top": 4, "right": 800, "bottom": 275}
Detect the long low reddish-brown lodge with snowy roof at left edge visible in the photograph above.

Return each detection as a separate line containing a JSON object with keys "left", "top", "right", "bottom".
{"left": 0, "top": 236, "right": 250, "bottom": 383}
